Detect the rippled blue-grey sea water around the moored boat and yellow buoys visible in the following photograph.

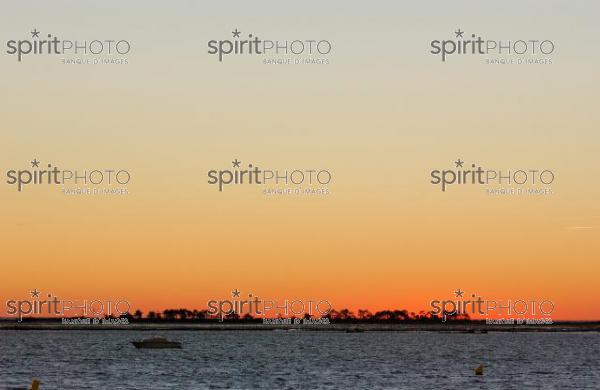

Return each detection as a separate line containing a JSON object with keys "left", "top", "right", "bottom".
{"left": 0, "top": 331, "right": 600, "bottom": 390}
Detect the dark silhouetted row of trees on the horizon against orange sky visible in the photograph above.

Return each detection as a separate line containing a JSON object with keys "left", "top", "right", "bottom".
{"left": 122, "top": 308, "right": 471, "bottom": 323}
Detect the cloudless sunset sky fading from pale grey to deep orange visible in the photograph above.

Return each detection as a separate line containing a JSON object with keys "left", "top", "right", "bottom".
{"left": 0, "top": 1, "right": 600, "bottom": 319}
